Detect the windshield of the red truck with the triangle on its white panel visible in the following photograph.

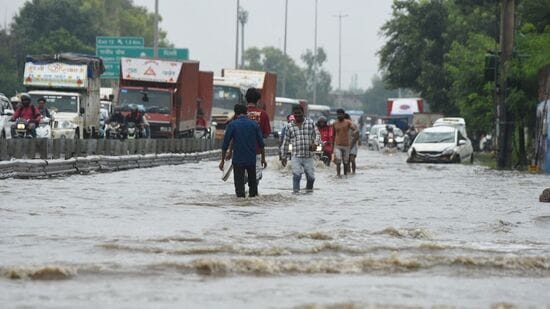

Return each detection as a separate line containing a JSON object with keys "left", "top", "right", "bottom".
{"left": 118, "top": 89, "right": 171, "bottom": 114}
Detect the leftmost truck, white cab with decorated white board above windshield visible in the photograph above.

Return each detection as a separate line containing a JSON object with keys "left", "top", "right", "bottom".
{"left": 23, "top": 53, "right": 105, "bottom": 139}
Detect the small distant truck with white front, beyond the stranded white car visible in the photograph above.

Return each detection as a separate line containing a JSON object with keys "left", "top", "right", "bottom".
{"left": 383, "top": 98, "right": 424, "bottom": 131}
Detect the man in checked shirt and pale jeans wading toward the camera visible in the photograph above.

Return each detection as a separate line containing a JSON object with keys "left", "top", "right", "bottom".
{"left": 280, "top": 105, "right": 321, "bottom": 193}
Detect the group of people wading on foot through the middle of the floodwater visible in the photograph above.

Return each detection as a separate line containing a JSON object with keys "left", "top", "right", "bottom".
{"left": 219, "top": 88, "right": 359, "bottom": 197}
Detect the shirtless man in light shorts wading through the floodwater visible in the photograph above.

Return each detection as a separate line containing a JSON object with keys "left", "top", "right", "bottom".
{"left": 332, "top": 108, "right": 359, "bottom": 177}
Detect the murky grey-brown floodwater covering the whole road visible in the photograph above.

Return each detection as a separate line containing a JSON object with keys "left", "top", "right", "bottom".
{"left": 0, "top": 147, "right": 550, "bottom": 308}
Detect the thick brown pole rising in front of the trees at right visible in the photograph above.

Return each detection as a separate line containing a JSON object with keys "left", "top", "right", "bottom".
{"left": 497, "top": 0, "right": 515, "bottom": 169}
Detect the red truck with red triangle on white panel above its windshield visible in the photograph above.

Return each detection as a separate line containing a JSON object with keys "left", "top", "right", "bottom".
{"left": 117, "top": 57, "right": 213, "bottom": 138}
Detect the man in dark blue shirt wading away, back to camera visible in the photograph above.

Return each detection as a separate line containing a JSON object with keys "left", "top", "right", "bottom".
{"left": 219, "top": 104, "right": 267, "bottom": 197}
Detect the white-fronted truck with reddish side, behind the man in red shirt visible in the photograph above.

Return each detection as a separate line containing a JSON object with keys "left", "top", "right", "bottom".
{"left": 212, "top": 69, "right": 277, "bottom": 138}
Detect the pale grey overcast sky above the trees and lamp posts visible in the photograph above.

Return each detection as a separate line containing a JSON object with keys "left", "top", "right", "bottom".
{"left": 0, "top": 0, "right": 392, "bottom": 89}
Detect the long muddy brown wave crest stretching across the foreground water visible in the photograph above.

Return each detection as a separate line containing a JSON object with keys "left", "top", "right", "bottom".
{"left": 0, "top": 253, "right": 550, "bottom": 280}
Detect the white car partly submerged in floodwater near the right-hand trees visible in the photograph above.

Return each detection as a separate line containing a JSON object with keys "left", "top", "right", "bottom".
{"left": 407, "top": 126, "right": 474, "bottom": 163}
